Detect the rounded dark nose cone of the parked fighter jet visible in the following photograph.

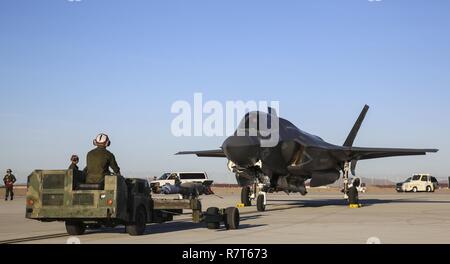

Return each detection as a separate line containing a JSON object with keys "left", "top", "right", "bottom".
{"left": 222, "top": 136, "right": 260, "bottom": 167}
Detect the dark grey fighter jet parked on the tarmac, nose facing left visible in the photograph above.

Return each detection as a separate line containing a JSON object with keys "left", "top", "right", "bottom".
{"left": 177, "top": 105, "right": 438, "bottom": 211}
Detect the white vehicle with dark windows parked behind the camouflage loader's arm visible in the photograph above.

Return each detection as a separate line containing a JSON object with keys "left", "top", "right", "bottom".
{"left": 150, "top": 172, "right": 209, "bottom": 193}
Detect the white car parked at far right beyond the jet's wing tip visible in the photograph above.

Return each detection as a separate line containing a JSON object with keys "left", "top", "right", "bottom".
{"left": 396, "top": 174, "right": 439, "bottom": 192}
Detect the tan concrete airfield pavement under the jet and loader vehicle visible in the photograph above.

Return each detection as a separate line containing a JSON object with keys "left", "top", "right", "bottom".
{"left": 0, "top": 188, "right": 450, "bottom": 244}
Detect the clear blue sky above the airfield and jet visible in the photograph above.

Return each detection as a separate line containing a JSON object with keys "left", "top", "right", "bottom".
{"left": 0, "top": 0, "right": 450, "bottom": 182}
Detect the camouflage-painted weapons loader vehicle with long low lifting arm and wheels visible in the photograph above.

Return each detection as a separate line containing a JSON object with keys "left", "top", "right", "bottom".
{"left": 26, "top": 170, "right": 240, "bottom": 236}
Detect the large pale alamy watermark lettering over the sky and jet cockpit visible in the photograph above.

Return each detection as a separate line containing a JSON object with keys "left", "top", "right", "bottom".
{"left": 171, "top": 93, "right": 280, "bottom": 147}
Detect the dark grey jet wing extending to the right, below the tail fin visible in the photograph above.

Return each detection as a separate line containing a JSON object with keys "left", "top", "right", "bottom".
{"left": 344, "top": 147, "right": 439, "bottom": 160}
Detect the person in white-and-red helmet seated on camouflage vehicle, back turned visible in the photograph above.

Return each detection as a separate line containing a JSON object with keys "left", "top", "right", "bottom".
{"left": 85, "top": 134, "right": 120, "bottom": 184}
